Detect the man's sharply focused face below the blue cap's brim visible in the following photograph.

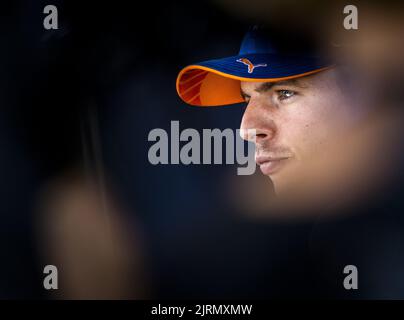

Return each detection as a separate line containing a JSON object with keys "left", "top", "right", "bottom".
{"left": 241, "top": 69, "right": 356, "bottom": 193}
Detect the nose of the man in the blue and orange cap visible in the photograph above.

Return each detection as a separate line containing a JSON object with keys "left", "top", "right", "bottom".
{"left": 240, "top": 102, "right": 276, "bottom": 144}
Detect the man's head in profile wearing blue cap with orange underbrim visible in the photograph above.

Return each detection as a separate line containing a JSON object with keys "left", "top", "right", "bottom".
{"left": 177, "top": 27, "right": 366, "bottom": 205}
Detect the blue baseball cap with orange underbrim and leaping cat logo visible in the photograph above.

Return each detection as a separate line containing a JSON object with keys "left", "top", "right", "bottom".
{"left": 176, "top": 27, "right": 333, "bottom": 106}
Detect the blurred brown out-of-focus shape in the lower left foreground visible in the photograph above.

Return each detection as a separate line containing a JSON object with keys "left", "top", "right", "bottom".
{"left": 38, "top": 172, "right": 146, "bottom": 299}
